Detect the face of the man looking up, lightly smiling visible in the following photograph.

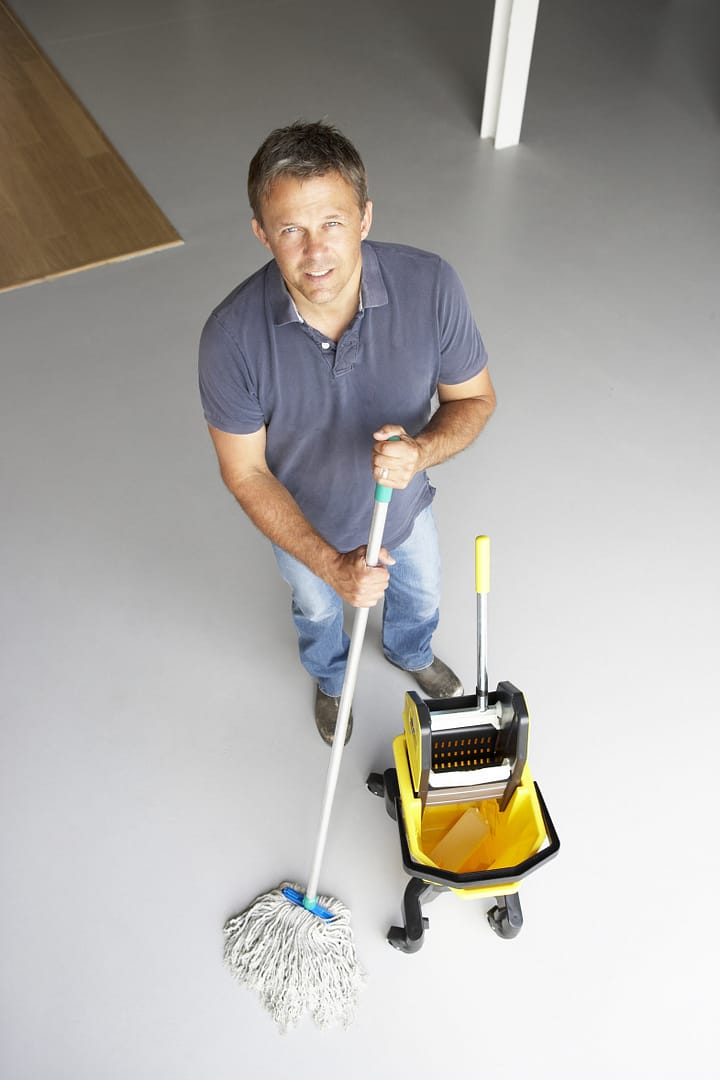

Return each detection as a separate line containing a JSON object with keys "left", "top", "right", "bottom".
{"left": 253, "top": 173, "right": 372, "bottom": 313}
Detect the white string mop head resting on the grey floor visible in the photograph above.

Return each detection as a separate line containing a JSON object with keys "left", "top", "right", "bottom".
{"left": 225, "top": 882, "right": 365, "bottom": 1031}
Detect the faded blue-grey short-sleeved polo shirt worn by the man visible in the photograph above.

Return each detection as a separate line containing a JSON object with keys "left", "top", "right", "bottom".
{"left": 200, "top": 240, "right": 487, "bottom": 551}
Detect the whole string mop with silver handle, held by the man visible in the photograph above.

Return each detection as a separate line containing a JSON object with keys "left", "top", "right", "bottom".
{"left": 225, "top": 475, "right": 393, "bottom": 1031}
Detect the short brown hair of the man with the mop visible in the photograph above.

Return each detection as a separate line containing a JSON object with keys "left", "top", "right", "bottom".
{"left": 247, "top": 120, "right": 367, "bottom": 224}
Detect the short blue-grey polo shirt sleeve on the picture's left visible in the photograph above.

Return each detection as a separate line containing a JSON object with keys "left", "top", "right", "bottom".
{"left": 199, "top": 314, "right": 264, "bottom": 435}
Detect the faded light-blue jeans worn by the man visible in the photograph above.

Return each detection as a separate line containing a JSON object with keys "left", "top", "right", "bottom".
{"left": 272, "top": 507, "right": 440, "bottom": 698}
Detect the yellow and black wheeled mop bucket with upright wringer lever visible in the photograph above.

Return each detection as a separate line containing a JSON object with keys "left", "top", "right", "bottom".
{"left": 367, "top": 537, "right": 560, "bottom": 953}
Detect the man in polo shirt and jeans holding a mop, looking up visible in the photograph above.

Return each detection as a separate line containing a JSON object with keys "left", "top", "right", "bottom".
{"left": 200, "top": 123, "right": 495, "bottom": 744}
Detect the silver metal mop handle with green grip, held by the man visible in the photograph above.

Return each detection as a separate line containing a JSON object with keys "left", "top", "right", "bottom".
{"left": 302, "top": 484, "right": 393, "bottom": 914}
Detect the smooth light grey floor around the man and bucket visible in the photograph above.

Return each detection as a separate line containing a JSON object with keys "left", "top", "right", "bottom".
{"left": 0, "top": 0, "right": 720, "bottom": 1080}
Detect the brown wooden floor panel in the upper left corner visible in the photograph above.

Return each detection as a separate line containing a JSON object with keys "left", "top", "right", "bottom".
{"left": 0, "top": 0, "right": 182, "bottom": 292}
